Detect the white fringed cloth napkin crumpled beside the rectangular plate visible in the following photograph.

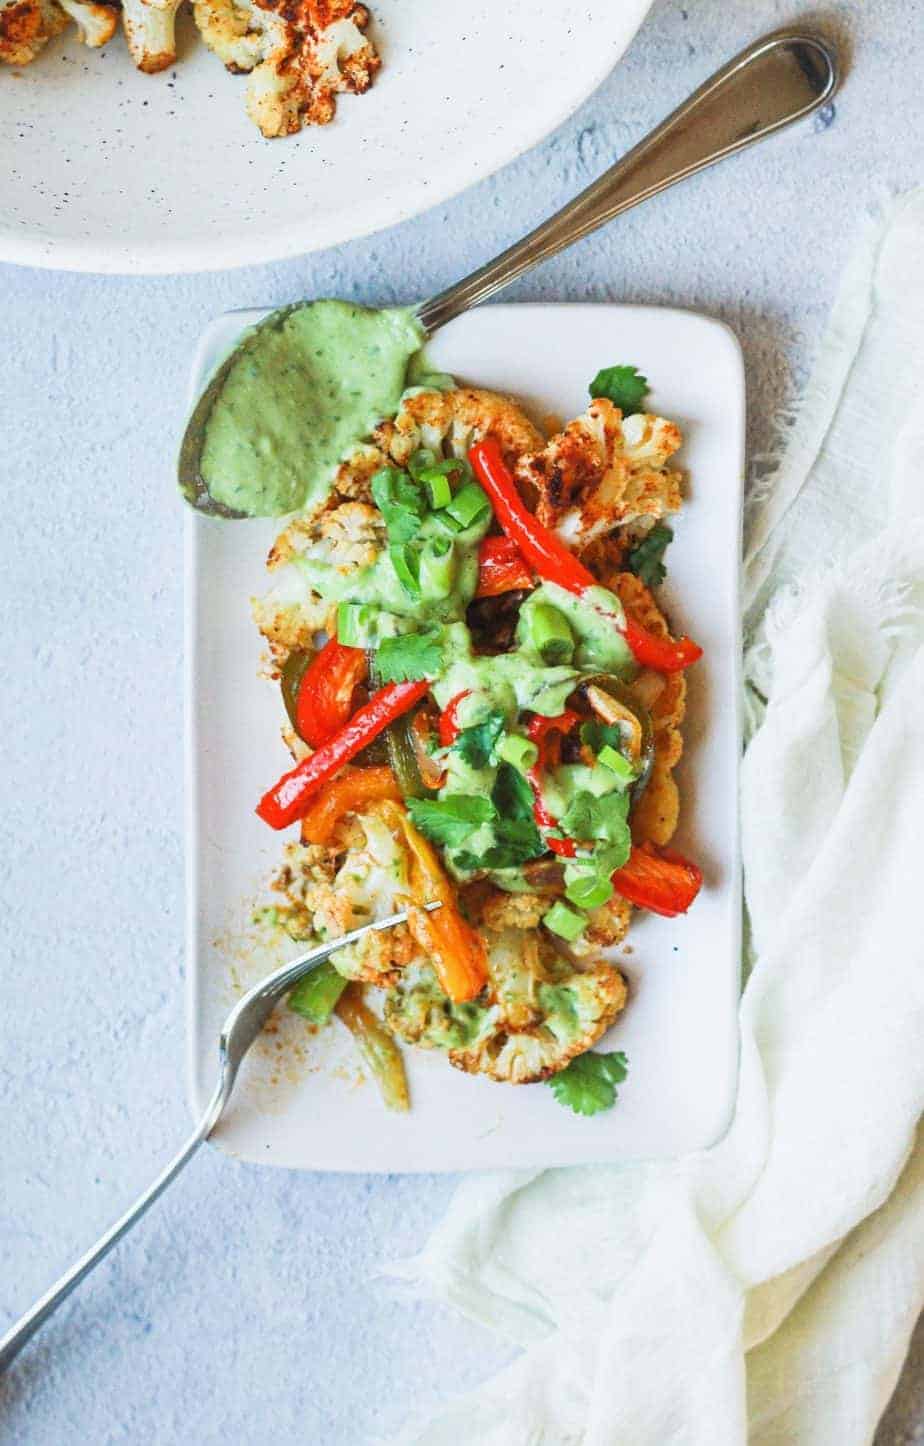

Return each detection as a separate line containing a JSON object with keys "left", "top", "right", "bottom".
{"left": 395, "top": 192, "right": 924, "bottom": 1446}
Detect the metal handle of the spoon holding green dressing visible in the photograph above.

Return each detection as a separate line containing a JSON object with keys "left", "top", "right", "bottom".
{"left": 418, "top": 30, "right": 837, "bottom": 333}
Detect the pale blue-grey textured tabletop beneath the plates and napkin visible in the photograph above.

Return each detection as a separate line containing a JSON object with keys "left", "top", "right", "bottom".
{"left": 0, "top": 0, "right": 924, "bottom": 1446}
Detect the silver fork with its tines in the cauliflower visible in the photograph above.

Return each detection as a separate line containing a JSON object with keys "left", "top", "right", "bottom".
{"left": 0, "top": 904, "right": 442, "bottom": 1371}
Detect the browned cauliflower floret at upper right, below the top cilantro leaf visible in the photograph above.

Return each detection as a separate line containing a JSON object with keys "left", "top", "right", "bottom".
{"left": 516, "top": 398, "right": 683, "bottom": 551}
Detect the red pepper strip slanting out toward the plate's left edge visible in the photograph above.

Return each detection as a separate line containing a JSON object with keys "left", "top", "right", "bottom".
{"left": 256, "top": 678, "right": 429, "bottom": 829}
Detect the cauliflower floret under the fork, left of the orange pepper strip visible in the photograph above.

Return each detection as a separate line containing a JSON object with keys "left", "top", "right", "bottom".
{"left": 273, "top": 807, "right": 415, "bottom": 985}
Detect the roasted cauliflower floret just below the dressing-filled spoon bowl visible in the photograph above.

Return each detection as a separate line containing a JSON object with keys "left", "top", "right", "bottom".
{"left": 250, "top": 502, "right": 386, "bottom": 658}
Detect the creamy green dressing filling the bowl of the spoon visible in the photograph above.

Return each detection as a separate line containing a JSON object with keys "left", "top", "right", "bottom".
{"left": 200, "top": 301, "right": 424, "bottom": 518}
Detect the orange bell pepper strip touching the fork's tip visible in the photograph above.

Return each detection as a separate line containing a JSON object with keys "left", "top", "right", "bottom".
{"left": 382, "top": 803, "right": 487, "bottom": 1004}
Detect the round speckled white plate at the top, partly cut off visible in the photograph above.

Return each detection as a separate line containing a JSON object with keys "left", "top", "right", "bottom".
{"left": 0, "top": 0, "right": 651, "bottom": 273}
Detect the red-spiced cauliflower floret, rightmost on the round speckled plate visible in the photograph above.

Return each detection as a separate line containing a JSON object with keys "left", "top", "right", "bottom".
{"left": 194, "top": 0, "right": 382, "bottom": 137}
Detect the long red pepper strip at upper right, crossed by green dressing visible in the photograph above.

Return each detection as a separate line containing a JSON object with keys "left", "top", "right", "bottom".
{"left": 469, "top": 437, "right": 703, "bottom": 672}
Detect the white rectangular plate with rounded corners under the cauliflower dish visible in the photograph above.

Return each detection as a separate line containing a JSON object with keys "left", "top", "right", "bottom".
{"left": 187, "top": 305, "right": 745, "bottom": 1171}
